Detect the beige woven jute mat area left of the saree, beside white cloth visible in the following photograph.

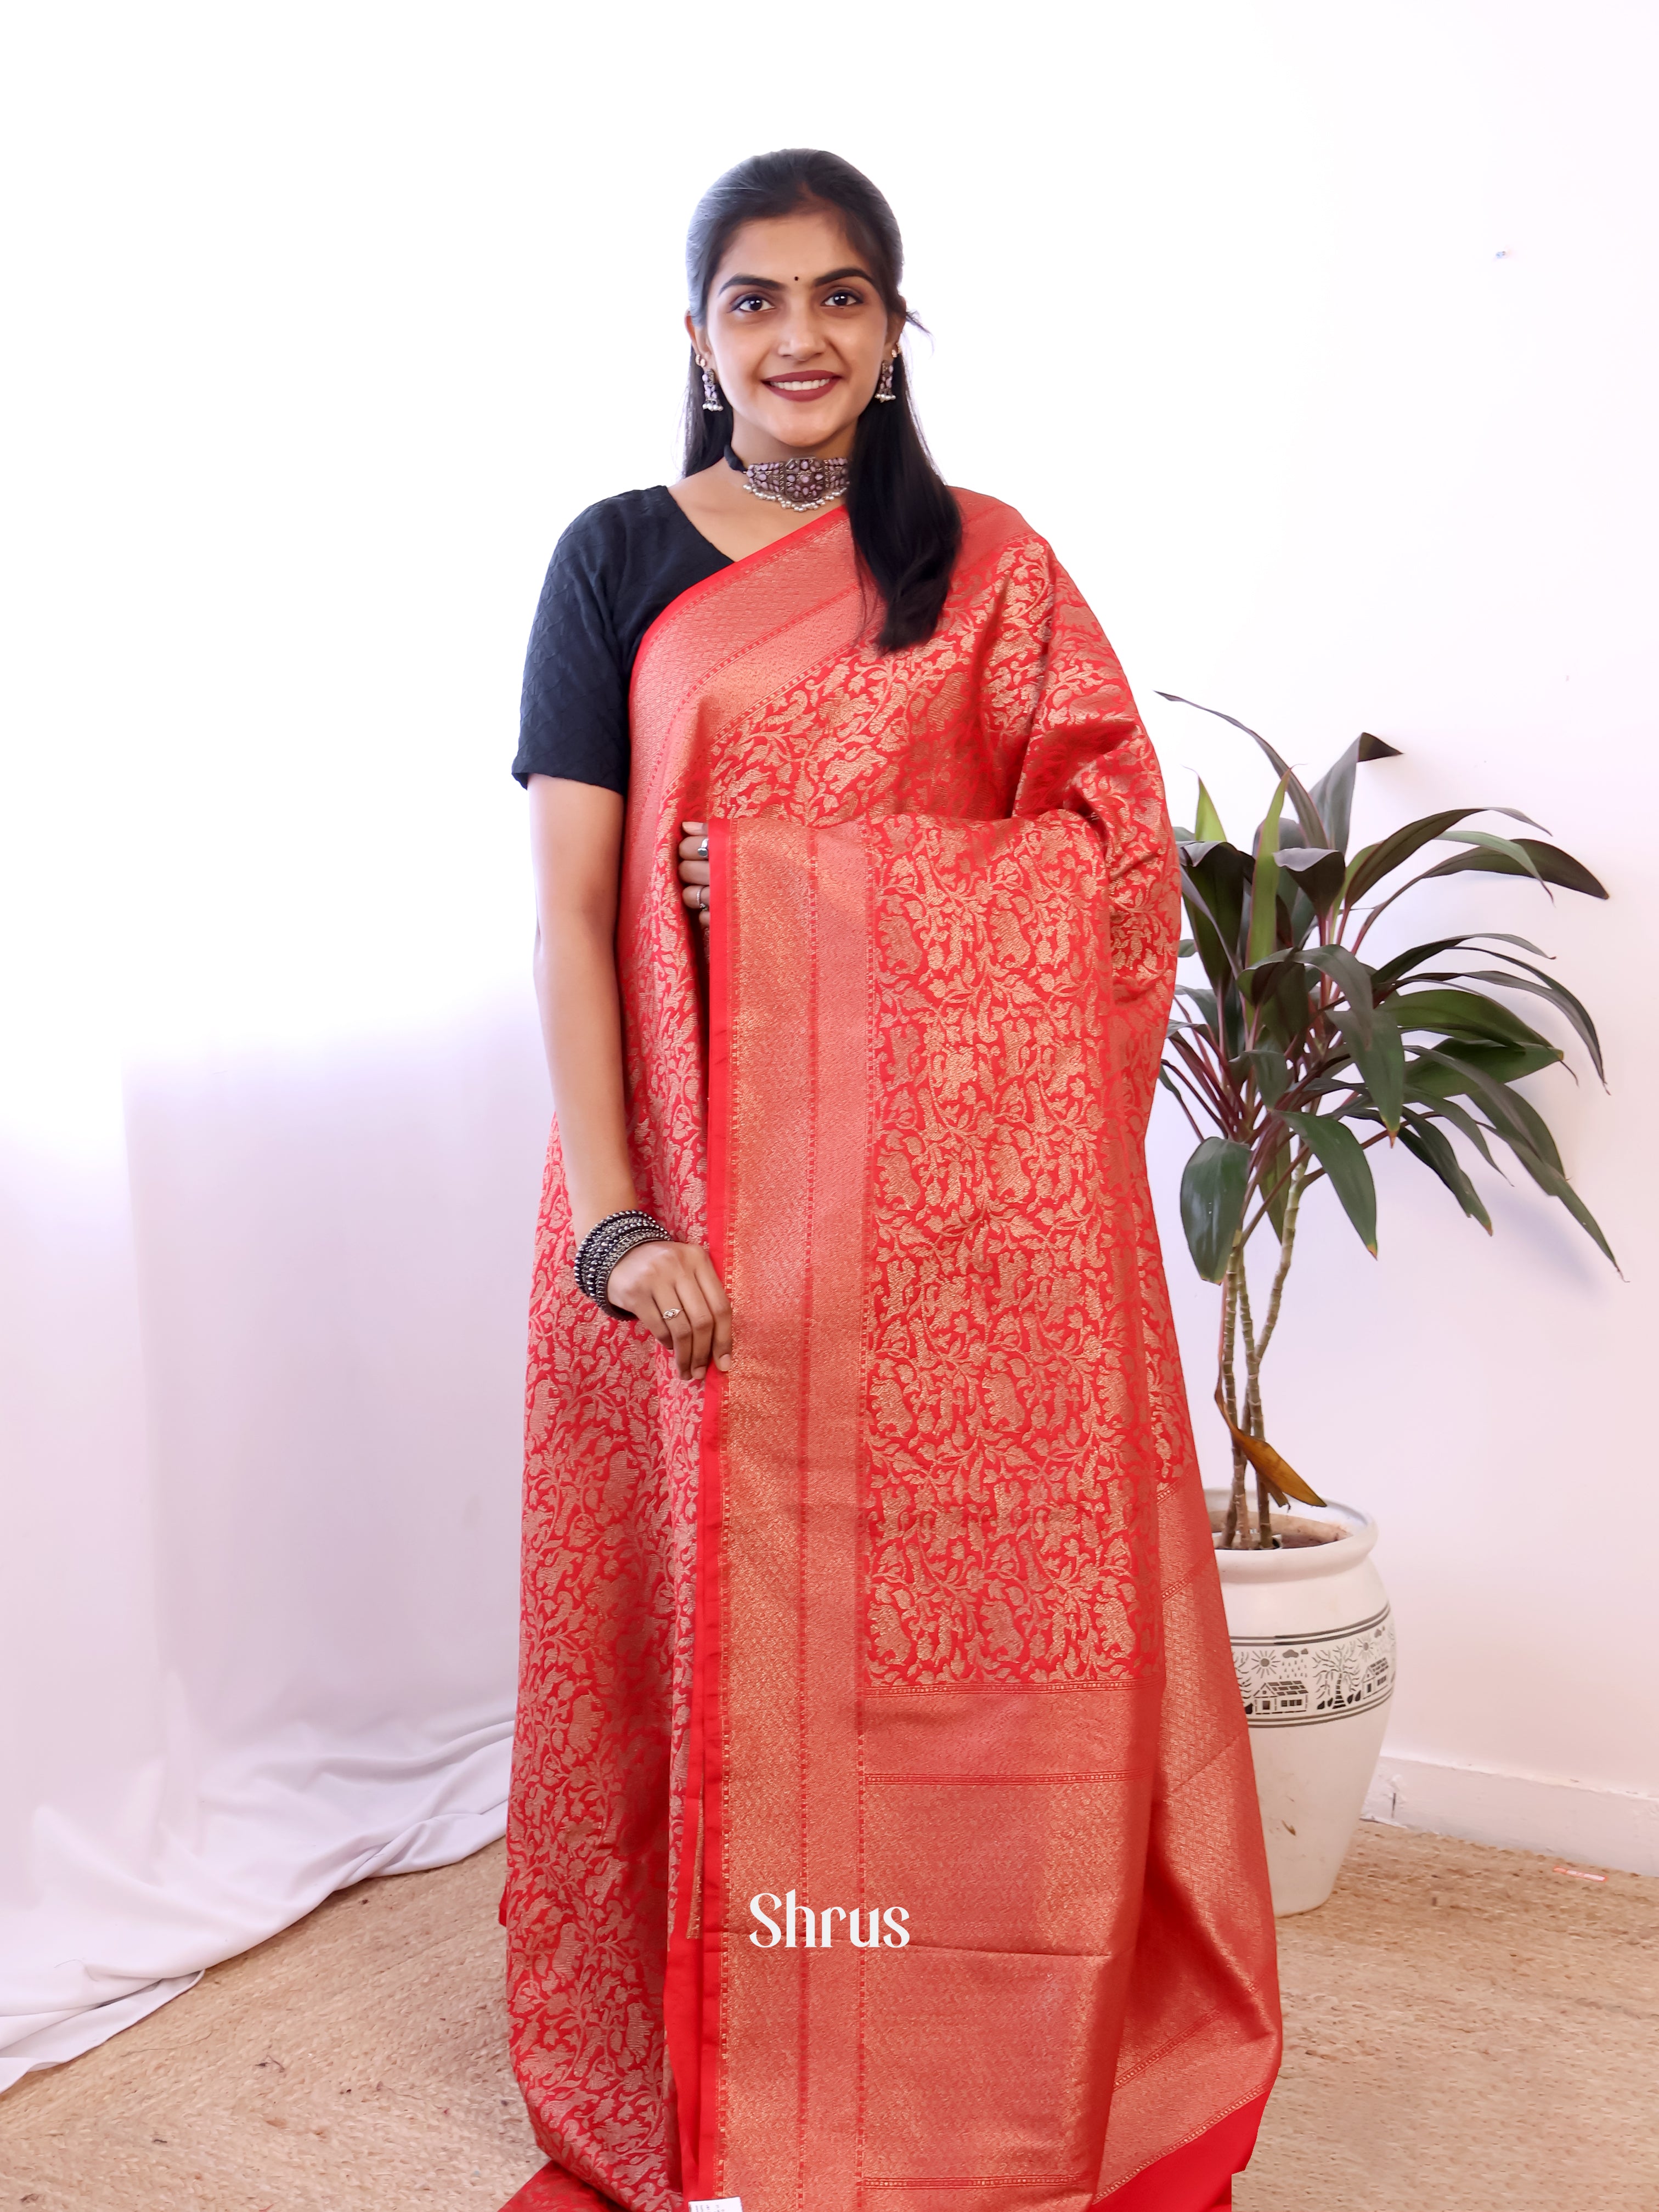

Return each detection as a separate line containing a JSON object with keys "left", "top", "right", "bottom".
{"left": 0, "top": 1845, "right": 542, "bottom": 2212}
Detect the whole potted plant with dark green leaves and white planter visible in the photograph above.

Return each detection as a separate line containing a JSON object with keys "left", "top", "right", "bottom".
{"left": 1159, "top": 692, "right": 1612, "bottom": 1914}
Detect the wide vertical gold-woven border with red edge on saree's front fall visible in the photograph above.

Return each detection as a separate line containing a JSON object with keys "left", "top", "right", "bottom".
{"left": 666, "top": 821, "right": 870, "bottom": 2212}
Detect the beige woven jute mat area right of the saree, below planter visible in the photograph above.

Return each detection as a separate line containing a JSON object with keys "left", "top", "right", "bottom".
{"left": 1234, "top": 1822, "right": 1659, "bottom": 2212}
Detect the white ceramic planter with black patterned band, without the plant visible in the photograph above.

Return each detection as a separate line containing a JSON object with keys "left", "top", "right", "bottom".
{"left": 1205, "top": 1491, "right": 1393, "bottom": 1914}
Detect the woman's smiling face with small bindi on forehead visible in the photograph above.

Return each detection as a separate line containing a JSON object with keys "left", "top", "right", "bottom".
{"left": 686, "top": 208, "right": 905, "bottom": 460}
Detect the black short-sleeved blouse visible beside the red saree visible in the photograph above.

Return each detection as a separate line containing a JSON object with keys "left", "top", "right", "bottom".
{"left": 513, "top": 484, "right": 732, "bottom": 794}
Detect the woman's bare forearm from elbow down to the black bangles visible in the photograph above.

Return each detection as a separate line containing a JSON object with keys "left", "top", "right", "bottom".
{"left": 535, "top": 911, "right": 639, "bottom": 1239}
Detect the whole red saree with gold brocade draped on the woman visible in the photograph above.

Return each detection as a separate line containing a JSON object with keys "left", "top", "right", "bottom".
{"left": 504, "top": 493, "right": 1278, "bottom": 2212}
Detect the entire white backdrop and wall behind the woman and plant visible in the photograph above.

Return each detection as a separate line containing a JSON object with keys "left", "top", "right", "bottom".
{"left": 0, "top": 0, "right": 1659, "bottom": 2073}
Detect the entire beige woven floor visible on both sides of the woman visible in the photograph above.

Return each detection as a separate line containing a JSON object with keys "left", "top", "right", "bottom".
{"left": 0, "top": 1825, "right": 1659, "bottom": 2212}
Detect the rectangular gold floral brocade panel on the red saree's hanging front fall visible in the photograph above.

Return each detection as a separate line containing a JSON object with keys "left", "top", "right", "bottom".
{"left": 865, "top": 819, "right": 1157, "bottom": 1688}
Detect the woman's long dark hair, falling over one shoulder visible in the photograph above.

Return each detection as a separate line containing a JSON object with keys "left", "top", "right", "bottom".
{"left": 686, "top": 146, "right": 962, "bottom": 652}
